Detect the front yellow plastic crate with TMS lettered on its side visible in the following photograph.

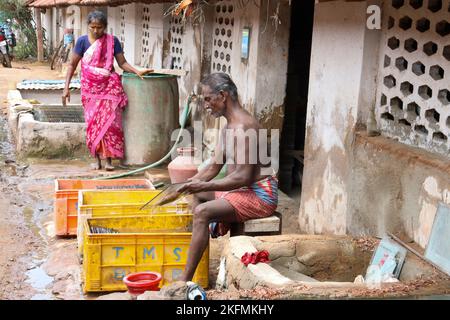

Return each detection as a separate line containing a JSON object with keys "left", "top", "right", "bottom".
{"left": 83, "top": 214, "right": 209, "bottom": 292}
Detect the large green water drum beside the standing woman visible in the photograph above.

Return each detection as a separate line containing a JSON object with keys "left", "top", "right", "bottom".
{"left": 122, "top": 73, "right": 179, "bottom": 165}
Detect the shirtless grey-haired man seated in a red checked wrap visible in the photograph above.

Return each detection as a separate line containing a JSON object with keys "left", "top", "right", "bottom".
{"left": 178, "top": 73, "right": 278, "bottom": 281}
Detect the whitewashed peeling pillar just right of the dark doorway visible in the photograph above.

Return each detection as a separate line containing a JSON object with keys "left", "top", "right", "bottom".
{"left": 299, "top": 2, "right": 375, "bottom": 234}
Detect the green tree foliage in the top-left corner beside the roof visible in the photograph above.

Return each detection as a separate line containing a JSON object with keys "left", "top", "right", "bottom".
{"left": 0, "top": 0, "right": 45, "bottom": 59}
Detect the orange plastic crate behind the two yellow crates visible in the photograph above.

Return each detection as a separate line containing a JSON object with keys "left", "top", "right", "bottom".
{"left": 54, "top": 179, "right": 155, "bottom": 236}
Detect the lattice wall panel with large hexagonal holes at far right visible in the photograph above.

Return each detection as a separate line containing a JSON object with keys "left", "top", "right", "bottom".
{"left": 376, "top": 1, "right": 450, "bottom": 157}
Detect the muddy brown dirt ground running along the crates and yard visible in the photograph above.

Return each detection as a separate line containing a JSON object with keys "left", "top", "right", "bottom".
{"left": 0, "top": 62, "right": 299, "bottom": 300}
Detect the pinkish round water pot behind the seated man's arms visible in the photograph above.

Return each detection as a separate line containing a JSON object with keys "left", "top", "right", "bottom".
{"left": 167, "top": 147, "right": 198, "bottom": 183}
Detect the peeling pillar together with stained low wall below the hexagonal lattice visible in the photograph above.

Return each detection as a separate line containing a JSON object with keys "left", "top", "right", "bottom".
{"left": 299, "top": 2, "right": 450, "bottom": 248}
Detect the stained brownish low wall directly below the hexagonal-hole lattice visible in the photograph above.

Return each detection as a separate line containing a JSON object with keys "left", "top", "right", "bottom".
{"left": 347, "top": 133, "right": 450, "bottom": 248}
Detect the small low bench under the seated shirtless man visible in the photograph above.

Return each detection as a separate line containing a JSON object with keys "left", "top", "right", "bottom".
{"left": 230, "top": 211, "right": 282, "bottom": 237}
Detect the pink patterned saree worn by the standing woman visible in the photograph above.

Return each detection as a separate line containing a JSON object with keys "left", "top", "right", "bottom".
{"left": 81, "top": 34, "right": 128, "bottom": 158}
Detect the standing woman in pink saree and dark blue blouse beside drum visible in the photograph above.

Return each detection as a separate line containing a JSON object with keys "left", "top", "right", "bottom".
{"left": 62, "top": 11, "right": 152, "bottom": 171}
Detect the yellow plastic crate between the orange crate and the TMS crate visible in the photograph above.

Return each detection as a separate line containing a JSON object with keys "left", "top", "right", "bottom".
{"left": 77, "top": 190, "right": 190, "bottom": 258}
